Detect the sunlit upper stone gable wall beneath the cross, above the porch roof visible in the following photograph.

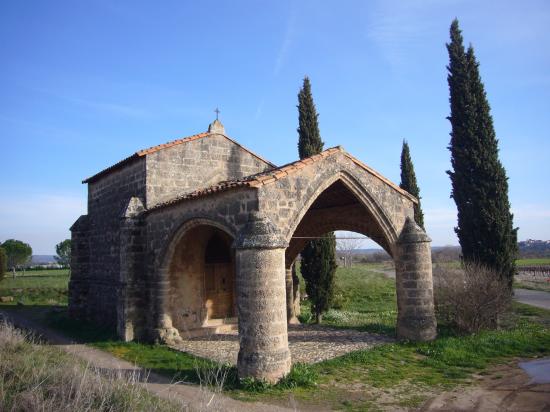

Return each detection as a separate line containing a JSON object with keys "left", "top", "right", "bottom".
{"left": 147, "top": 134, "right": 272, "bottom": 208}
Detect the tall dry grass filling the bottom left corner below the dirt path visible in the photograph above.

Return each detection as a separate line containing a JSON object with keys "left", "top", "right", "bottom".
{"left": 0, "top": 323, "right": 181, "bottom": 412}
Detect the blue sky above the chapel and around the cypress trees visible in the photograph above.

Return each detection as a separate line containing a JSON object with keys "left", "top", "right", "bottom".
{"left": 0, "top": 0, "right": 550, "bottom": 254}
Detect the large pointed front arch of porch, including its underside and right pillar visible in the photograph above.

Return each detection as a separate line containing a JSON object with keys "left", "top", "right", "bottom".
{"left": 285, "top": 171, "right": 435, "bottom": 340}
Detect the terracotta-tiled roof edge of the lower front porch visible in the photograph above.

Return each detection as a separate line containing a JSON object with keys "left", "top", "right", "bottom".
{"left": 149, "top": 146, "right": 418, "bottom": 210}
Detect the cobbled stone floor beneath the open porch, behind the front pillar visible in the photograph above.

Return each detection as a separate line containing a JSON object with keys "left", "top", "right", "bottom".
{"left": 171, "top": 325, "right": 393, "bottom": 364}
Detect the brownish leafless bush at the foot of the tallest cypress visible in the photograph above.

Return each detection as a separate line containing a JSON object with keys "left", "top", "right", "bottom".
{"left": 434, "top": 263, "right": 511, "bottom": 333}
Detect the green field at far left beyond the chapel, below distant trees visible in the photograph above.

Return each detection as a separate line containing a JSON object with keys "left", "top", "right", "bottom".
{"left": 0, "top": 269, "right": 69, "bottom": 305}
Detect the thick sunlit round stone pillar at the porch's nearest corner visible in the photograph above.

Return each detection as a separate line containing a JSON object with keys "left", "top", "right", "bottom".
{"left": 235, "top": 213, "right": 291, "bottom": 383}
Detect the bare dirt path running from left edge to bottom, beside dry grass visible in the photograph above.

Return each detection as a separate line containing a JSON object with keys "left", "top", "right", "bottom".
{"left": 0, "top": 311, "right": 290, "bottom": 412}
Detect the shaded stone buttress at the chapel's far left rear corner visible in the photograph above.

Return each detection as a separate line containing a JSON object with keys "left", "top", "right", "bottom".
{"left": 69, "top": 215, "right": 90, "bottom": 319}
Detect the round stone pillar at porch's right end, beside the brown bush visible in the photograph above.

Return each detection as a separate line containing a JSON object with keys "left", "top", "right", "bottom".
{"left": 395, "top": 218, "right": 437, "bottom": 341}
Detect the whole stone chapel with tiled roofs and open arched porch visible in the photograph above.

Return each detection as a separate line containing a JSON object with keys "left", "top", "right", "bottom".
{"left": 69, "top": 120, "right": 436, "bottom": 382}
